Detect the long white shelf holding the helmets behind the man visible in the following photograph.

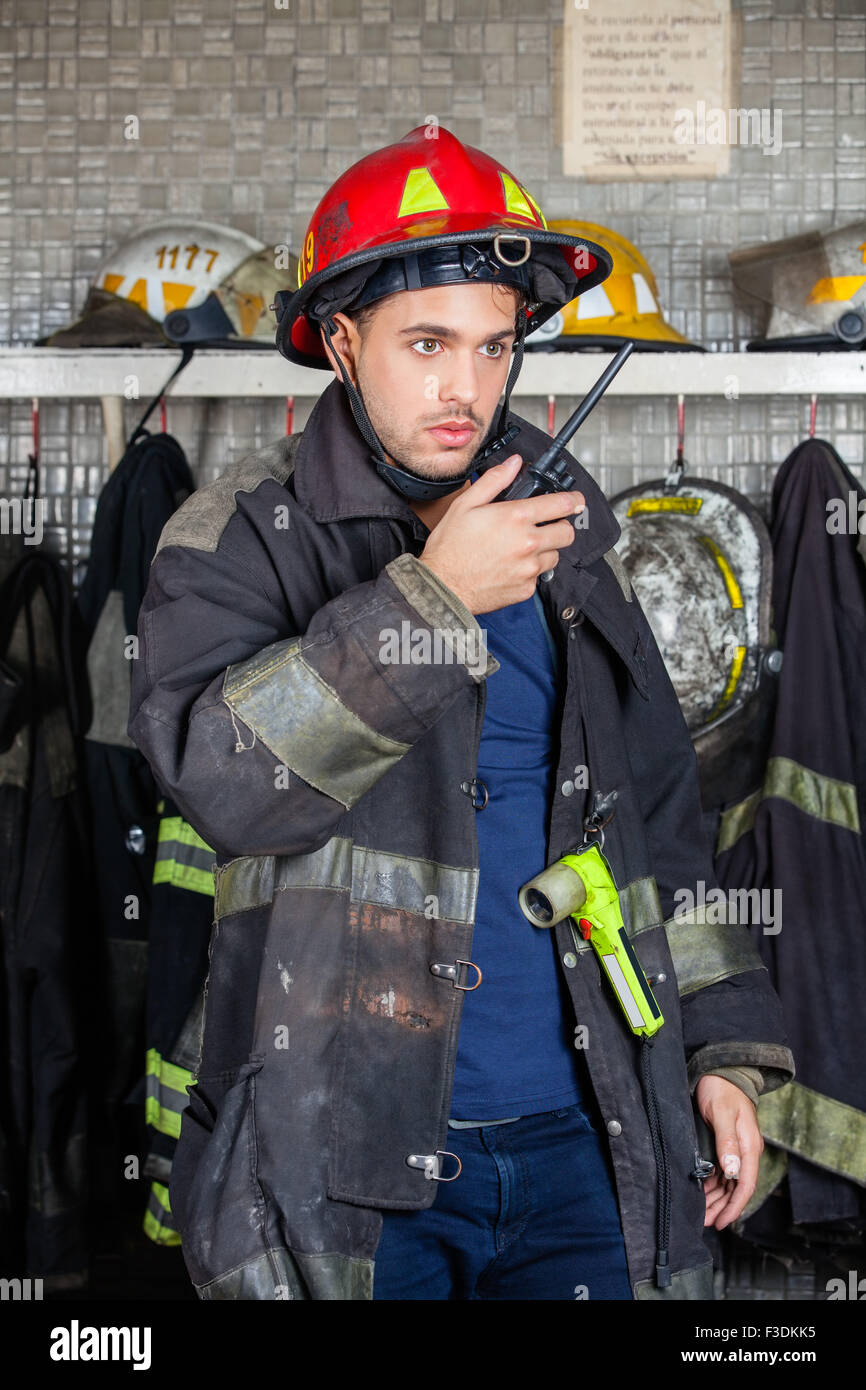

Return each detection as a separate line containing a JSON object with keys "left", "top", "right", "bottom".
{"left": 0, "top": 348, "right": 866, "bottom": 402}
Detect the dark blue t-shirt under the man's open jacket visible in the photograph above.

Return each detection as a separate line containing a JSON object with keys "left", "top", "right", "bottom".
{"left": 450, "top": 581, "right": 581, "bottom": 1120}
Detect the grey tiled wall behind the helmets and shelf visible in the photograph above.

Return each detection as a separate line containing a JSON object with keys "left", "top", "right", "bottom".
{"left": 0, "top": 0, "right": 866, "bottom": 582}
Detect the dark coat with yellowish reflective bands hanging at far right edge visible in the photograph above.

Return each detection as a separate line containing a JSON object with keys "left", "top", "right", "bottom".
{"left": 716, "top": 439, "right": 866, "bottom": 1234}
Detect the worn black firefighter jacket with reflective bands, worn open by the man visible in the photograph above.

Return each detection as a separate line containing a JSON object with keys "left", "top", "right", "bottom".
{"left": 129, "top": 382, "right": 794, "bottom": 1300}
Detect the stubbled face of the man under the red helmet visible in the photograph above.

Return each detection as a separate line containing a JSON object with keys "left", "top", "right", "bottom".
{"left": 322, "top": 282, "right": 517, "bottom": 478}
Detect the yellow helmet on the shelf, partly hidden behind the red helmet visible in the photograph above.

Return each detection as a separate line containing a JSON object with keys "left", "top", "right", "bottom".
{"left": 525, "top": 221, "right": 703, "bottom": 352}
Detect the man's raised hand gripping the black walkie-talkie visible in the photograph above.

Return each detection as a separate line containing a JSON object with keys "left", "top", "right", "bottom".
{"left": 418, "top": 453, "right": 587, "bottom": 613}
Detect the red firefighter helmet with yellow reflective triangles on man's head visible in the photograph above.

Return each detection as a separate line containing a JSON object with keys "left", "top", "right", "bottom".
{"left": 274, "top": 125, "right": 612, "bottom": 368}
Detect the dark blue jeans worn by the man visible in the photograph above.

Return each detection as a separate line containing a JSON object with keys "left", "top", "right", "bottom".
{"left": 373, "top": 1105, "right": 632, "bottom": 1300}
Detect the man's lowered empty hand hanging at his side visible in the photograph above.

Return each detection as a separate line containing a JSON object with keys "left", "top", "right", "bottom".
{"left": 695, "top": 1076, "right": 763, "bottom": 1230}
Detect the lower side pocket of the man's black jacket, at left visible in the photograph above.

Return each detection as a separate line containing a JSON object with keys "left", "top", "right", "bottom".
{"left": 168, "top": 1056, "right": 265, "bottom": 1284}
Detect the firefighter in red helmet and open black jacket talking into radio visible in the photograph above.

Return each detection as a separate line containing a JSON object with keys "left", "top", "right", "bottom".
{"left": 129, "top": 126, "right": 794, "bottom": 1300}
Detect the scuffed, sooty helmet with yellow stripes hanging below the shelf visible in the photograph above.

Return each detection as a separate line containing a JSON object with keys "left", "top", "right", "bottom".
{"left": 610, "top": 478, "right": 781, "bottom": 809}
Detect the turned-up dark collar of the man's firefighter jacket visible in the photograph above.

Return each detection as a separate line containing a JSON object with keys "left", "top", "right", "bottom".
{"left": 295, "top": 378, "right": 620, "bottom": 569}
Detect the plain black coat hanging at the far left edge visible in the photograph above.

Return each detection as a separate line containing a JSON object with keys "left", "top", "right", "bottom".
{"left": 0, "top": 552, "right": 97, "bottom": 1291}
